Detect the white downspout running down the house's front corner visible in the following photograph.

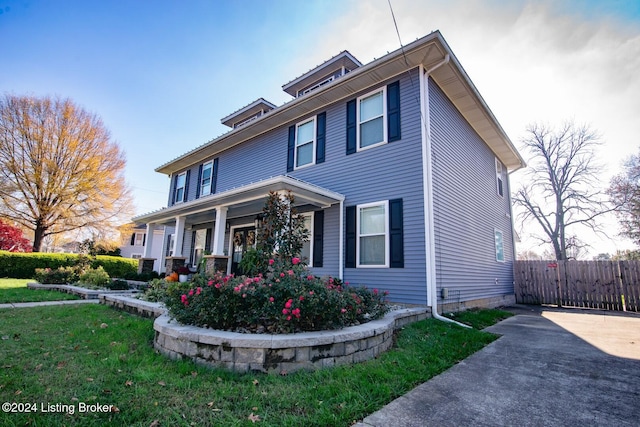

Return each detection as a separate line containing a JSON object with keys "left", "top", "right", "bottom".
{"left": 419, "top": 54, "right": 471, "bottom": 328}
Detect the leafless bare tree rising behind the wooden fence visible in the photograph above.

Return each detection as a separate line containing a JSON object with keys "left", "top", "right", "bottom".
{"left": 514, "top": 122, "right": 613, "bottom": 260}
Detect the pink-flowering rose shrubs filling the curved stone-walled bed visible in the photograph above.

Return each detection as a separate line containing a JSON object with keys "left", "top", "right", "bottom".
{"left": 165, "top": 259, "right": 388, "bottom": 333}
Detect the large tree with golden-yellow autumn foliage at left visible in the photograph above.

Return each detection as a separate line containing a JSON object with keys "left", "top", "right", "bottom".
{"left": 0, "top": 94, "right": 132, "bottom": 252}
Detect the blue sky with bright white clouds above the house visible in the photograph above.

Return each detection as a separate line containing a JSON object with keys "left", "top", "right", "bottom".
{"left": 0, "top": 0, "right": 640, "bottom": 254}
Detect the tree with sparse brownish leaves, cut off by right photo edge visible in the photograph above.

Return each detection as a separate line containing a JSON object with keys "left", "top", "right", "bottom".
{"left": 609, "top": 148, "right": 640, "bottom": 245}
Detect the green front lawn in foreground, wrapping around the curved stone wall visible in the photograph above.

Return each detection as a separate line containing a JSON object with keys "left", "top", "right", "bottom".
{"left": 0, "top": 305, "right": 510, "bottom": 427}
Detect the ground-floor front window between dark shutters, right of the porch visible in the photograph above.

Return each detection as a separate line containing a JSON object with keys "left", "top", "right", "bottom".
{"left": 356, "top": 200, "right": 389, "bottom": 267}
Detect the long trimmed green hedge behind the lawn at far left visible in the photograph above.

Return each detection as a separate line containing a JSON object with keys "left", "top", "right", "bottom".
{"left": 0, "top": 251, "right": 138, "bottom": 279}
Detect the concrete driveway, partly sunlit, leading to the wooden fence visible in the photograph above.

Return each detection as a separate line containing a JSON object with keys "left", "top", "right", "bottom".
{"left": 357, "top": 306, "right": 640, "bottom": 427}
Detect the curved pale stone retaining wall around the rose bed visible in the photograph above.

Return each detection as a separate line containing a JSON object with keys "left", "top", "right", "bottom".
{"left": 153, "top": 307, "right": 430, "bottom": 373}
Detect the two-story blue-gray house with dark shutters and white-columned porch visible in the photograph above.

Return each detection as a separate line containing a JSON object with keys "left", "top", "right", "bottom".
{"left": 134, "top": 32, "right": 524, "bottom": 306}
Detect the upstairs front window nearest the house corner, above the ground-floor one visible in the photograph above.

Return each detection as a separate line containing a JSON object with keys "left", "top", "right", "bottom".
{"left": 356, "top": 87, "right": 387, "bottom": 151}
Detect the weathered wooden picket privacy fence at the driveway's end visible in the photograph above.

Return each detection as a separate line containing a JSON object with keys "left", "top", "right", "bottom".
{"left": 514, "top": 261, "right": 640, "bottom": 312}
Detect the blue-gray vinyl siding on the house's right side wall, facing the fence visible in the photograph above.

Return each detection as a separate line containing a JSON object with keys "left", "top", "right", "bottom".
{"left": 429, "top": 79, "right": 514, "bottom": 301}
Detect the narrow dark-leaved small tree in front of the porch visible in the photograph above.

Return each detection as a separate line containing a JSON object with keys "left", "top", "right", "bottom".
{"left": 256, "top": 191, "right": 309, "bottom": 262}
